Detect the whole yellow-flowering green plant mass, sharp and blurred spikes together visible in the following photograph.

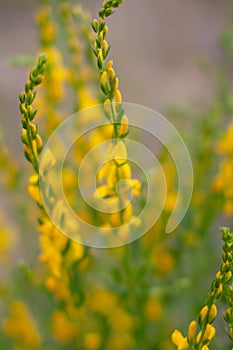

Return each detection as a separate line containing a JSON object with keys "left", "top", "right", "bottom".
{"left": 0, "top": 0, "right": 233, "bottom": 350}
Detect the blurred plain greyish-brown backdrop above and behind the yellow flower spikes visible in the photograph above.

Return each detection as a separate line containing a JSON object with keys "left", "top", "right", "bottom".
{"left": 0, "top": 0, "right": 233, "bottom": 154}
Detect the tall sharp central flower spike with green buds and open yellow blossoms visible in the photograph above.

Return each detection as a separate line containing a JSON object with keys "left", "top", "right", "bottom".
{"left": 92, "top": 2, "right": 141, "bottom": 231}
